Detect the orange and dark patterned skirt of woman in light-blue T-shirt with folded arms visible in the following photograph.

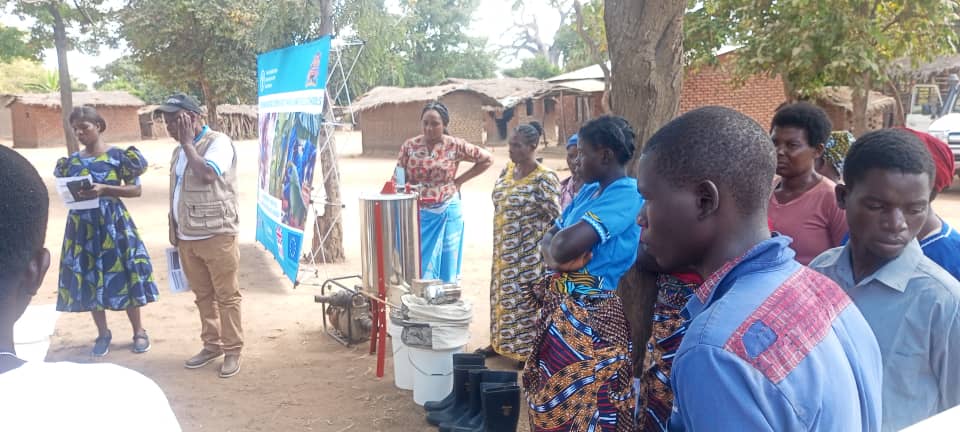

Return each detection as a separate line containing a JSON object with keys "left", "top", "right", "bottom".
{"left": 523, "top": 275, "right": 635, "bottom": 432}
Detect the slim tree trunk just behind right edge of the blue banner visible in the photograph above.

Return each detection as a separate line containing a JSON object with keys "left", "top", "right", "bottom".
{"left": 311, "top": 0, "right": 346, "bottom": 264}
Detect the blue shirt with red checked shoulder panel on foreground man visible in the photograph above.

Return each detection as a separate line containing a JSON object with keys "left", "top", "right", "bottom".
{"left": 670, "top": 236, "right": 882, "bottom": 431}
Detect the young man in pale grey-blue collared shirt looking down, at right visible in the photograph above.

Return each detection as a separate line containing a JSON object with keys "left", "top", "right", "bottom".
{"left": 810, "top": 129, "right": 960, "bottom": 431}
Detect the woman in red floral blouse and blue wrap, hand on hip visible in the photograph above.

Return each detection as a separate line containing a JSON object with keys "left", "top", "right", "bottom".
{"left": 397, "top": 102, "right": 493, "bottom": 282}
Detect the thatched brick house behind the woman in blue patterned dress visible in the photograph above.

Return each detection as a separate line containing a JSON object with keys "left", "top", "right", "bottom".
{"left": 6, "top": 92, "right": 143, "bottom": 148}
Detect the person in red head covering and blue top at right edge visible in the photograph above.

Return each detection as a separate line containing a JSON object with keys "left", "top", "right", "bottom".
{"left": 904, "top": 128, "right": 960, "bottom": 279}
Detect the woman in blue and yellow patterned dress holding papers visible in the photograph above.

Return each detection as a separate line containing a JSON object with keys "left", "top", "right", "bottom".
{"left": 54, "top": 107, "right": 158, "bottom": 357}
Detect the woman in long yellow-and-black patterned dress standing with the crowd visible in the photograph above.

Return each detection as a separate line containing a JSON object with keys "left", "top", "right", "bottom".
{"left": 478, "top": 122, "right": 560, "bottom": 362}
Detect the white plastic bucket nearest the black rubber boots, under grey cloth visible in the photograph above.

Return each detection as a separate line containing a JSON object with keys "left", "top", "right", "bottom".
{"left": 407, "top": 345, "right": 466, "bottom": 405}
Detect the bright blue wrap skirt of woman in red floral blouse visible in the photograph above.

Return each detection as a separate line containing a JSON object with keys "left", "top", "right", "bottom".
{"left": 420, "top": 196, "right": 463, "bottom": 283}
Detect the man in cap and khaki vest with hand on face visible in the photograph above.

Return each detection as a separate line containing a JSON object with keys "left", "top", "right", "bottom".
{"left": 157, "top": 93, "right": 243, "bottom": 378}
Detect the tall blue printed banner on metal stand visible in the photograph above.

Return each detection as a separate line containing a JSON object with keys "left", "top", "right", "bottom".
{"left": 257, "top": 36, "right": 330, "bottom": 281}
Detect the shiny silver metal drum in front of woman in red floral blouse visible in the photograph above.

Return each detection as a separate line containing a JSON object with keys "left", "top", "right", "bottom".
{"left": 360, "top": 193, "right": 420, "bottom": 304}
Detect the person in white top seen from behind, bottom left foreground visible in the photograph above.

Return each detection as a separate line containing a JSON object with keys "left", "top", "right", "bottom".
{"left": 0, "top": 146, "right": 180, "bottom": 432}
